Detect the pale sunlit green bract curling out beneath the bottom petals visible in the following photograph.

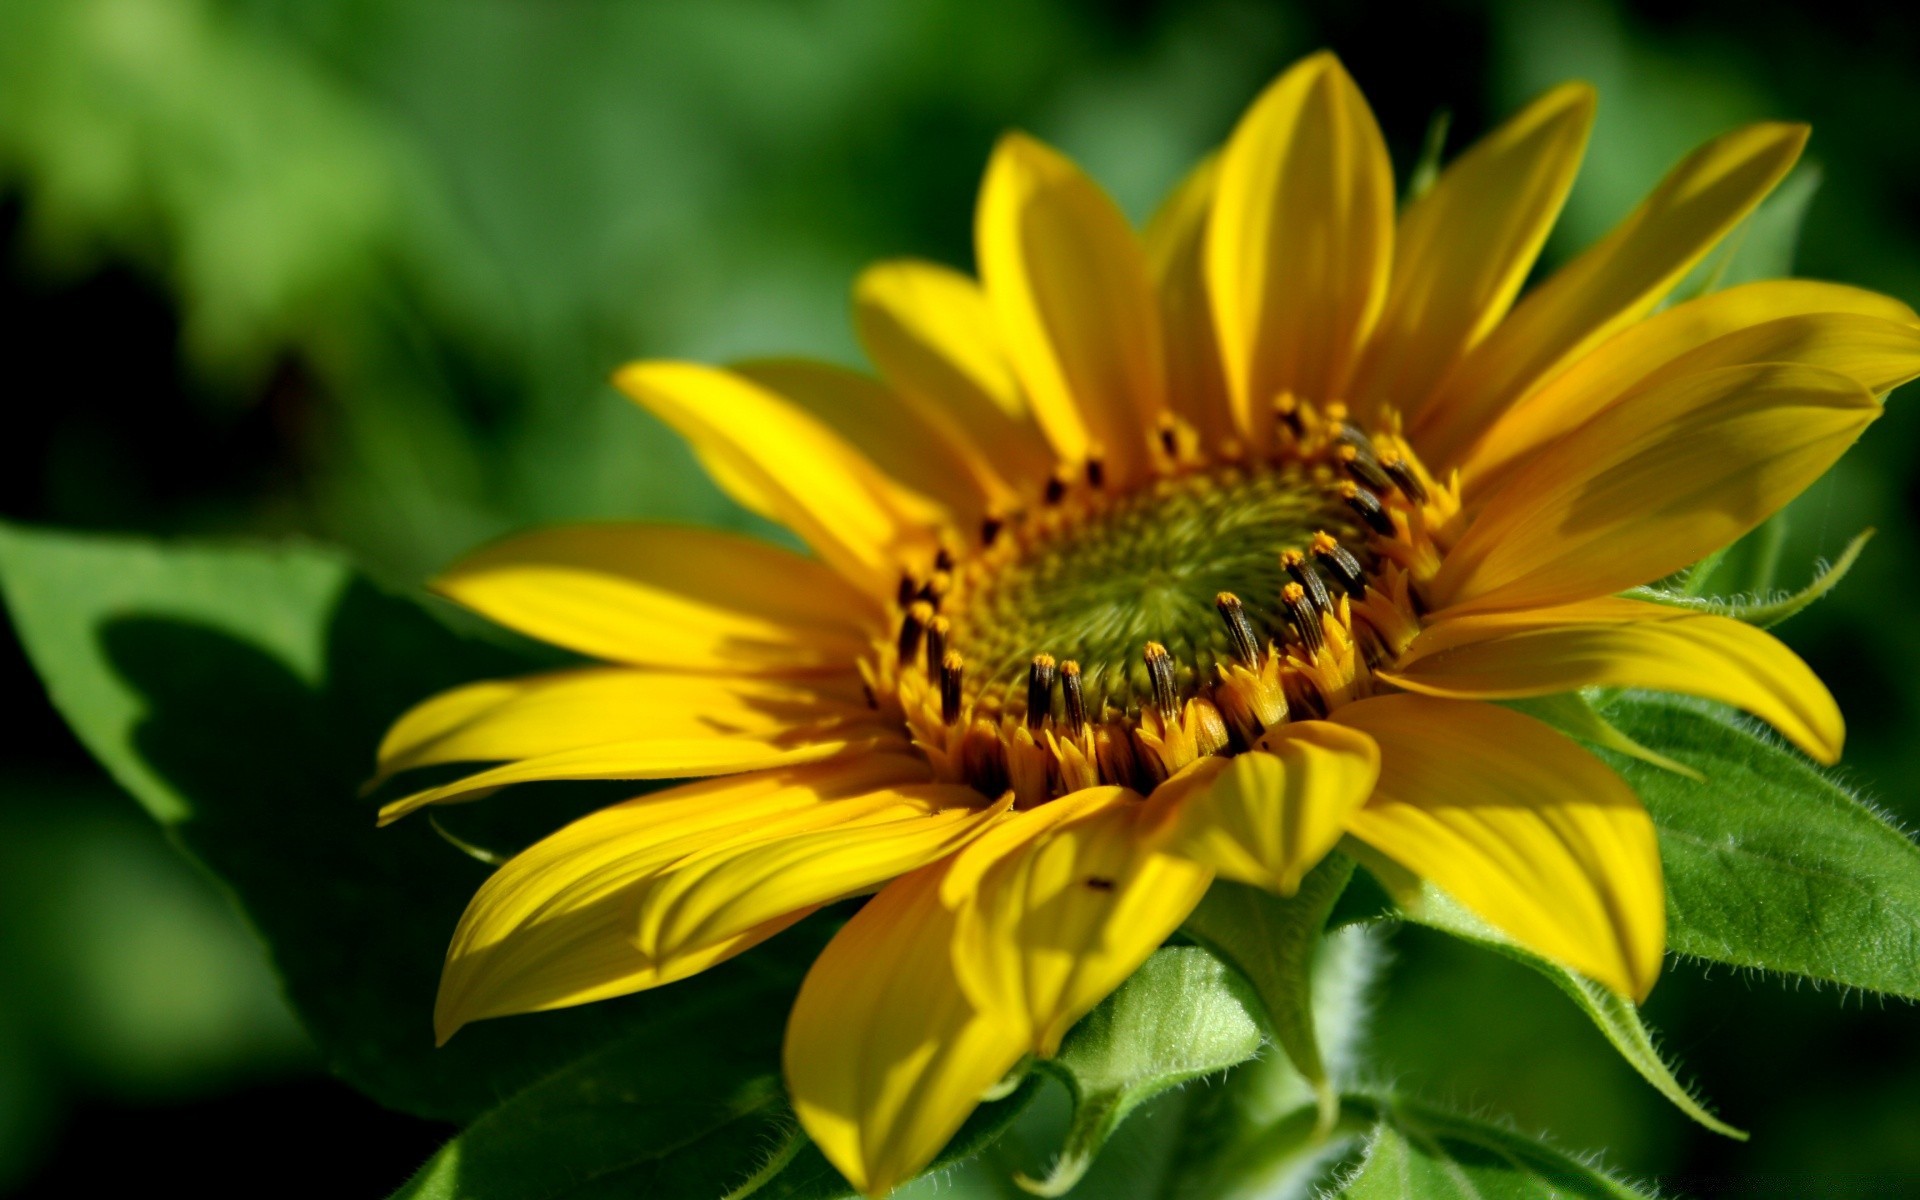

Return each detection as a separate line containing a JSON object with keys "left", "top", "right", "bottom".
{"left": 1020, "top": 947, "right": 1263, "bottom": 1196}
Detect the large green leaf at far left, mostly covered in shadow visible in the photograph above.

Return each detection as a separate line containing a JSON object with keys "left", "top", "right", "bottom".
{"left": 0, "top": 526, "right": 824, "bottom": 1121}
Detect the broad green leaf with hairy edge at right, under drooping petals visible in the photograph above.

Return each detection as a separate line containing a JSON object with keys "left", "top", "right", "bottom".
{"left": 1603, "top": 693, "right": 1920, "bottom": 998}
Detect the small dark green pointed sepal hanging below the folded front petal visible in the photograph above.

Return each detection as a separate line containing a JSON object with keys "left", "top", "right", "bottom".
{"left": 1185, "top": 854, "right": 1354, "bottom": 1125}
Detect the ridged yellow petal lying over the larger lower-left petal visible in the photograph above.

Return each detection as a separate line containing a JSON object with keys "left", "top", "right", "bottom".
{"left": 634, "top": 783, "right": 1014, "bottom": 970}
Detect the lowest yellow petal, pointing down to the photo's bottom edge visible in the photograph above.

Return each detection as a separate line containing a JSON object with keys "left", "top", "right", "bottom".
{"left": 785, "top": 860, "right": 1027, "bottom": 1196}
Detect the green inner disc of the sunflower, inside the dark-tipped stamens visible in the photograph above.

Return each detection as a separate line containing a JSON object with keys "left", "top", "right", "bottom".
{"left": 945, "top": 465, "right": 1363, "bottom": 712}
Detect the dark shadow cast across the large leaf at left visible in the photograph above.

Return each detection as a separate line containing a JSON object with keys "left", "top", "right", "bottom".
{"left": 91, "top": 582, "right": 833, "bottom": 1121}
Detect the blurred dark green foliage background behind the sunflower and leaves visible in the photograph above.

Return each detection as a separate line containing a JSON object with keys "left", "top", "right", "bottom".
{"left": 0, "top": 0, "right": 1920, "bottom": 1196}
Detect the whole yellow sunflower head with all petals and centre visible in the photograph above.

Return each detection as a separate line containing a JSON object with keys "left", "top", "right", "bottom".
{"left": 380, "top": 54, "right": 1920, "bottom": 1194}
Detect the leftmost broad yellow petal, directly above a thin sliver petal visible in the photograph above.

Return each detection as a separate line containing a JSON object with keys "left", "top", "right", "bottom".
{"left": 378, "top": 666, "right": 866, "bottom": 778}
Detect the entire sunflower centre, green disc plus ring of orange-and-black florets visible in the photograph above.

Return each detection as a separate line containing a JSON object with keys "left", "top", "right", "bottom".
{"left": 862, "top": 394, "right": 1457, "bottom": 808}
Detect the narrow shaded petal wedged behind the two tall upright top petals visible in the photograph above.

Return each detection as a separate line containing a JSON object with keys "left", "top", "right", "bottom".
{"left": 1146, "top": 157, "right": 1246, "bottom": 451}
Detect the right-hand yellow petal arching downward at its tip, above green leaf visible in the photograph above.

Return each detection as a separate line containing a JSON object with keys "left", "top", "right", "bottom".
{"left": 1380, "top": 599, "right": 1845, "bottom": 764}
